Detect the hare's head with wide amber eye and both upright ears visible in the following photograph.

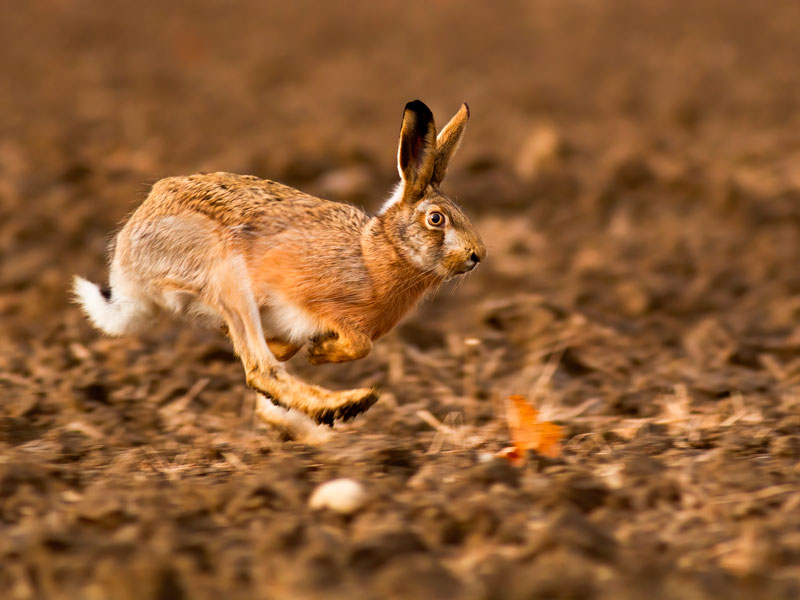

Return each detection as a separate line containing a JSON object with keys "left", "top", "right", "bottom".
{"left": 380, "top": 100, "right": 486, "bottom": 279}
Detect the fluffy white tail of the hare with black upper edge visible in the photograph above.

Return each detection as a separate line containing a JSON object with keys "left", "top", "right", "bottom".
{"left": 72, "top": 275, "right": 151, "bottom": 336}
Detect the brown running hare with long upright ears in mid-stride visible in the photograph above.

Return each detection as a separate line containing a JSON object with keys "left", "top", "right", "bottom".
{"left": 75, "top": 100, "right": 486, "bottom": 425}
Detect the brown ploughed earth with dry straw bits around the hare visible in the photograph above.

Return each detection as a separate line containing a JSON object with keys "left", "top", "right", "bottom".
{"left": 0, "top": 0, "right": 800, "bottom": 600}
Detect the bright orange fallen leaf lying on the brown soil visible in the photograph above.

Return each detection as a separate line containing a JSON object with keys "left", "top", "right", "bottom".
{"left": 497, "top": 394, "right": 564, "bottom": 464}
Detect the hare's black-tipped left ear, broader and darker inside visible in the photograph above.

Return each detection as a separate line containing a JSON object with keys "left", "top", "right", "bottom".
{"left": 397, "top": 100, "right": 436, "bottom": 203}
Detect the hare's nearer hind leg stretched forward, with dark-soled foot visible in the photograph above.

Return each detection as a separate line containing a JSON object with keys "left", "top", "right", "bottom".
{"left": 209, "top": 257, "right": 378, "bottom": 425}
